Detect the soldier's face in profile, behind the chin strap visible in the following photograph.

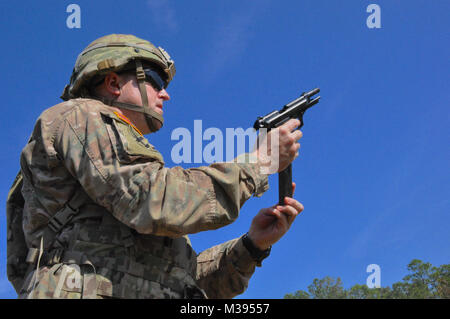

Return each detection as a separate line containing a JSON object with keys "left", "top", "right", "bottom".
{"left": 117, "top": 74, "right": 170, "bottom": 134}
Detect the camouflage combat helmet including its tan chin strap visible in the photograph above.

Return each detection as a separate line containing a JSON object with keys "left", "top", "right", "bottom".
{"left": 61, "top": 34, "right": 175, "bottom": 132}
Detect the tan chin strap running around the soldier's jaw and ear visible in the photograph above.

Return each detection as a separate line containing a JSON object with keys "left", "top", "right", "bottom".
{"left": 95, "top": 60, "right": 164, "bottom": 133}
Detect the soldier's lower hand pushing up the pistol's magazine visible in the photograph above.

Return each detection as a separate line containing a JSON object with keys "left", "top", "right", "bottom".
{"left": 248, "top": 183, "right": 303, "bottom": 250}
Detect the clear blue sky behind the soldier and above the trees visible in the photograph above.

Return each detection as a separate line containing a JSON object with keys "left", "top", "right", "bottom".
{"left": 0, "top": 0, "right": 450, "bottom": 298}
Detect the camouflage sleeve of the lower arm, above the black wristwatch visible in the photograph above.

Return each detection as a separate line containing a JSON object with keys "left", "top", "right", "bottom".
{"left": 197, "top": 238, "right": 256, "bottom": 299}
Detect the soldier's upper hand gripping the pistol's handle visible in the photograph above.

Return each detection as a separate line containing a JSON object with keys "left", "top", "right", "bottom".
{"left": 255, "top": 119, "right": 303, "bottom": 174}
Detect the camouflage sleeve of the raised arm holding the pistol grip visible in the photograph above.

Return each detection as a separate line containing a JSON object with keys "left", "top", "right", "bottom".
{"left": 55, "top": 105, "right": 268, "bottom": 237}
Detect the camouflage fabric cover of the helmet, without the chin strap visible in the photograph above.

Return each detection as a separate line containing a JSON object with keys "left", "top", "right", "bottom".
{"left": 61, "top": 34, "right": 175, "bottom": 100}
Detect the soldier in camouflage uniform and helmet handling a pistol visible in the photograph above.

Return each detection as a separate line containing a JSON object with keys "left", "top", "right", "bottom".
{"left": 8, "top": 34, "right": 303, "bottom": 298}
